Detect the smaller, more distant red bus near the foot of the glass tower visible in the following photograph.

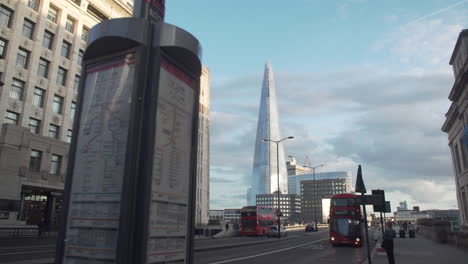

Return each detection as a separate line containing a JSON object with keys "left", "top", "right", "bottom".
{"left": 240, "top": 206, "right": 278, "bottom": 236}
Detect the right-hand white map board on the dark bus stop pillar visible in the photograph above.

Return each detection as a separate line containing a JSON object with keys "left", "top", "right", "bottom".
{"left": 147, "top": 58, "right": 198, "bottom": 263}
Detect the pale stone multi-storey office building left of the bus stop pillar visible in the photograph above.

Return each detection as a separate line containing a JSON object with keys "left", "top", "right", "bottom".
{"left": 0, "top": 0, "right": 133, "bottom": 228}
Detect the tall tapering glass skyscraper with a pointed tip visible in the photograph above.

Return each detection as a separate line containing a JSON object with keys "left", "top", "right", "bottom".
{"left": 247, "top": 61, "right": 288, "bottom": 205}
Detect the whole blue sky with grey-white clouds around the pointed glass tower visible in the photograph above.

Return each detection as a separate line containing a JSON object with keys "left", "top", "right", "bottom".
{"left": 165, "top": 0, "right": 468, "bottom": 210}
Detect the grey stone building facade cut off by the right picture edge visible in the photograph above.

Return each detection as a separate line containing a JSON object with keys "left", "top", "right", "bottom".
{"left": 442, "top": 29, "right": 468, "bottom": 232}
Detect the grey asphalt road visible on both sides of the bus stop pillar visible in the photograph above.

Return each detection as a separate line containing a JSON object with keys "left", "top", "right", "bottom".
{"left": 0, "top": 229, "right": 380, "bottom": 264}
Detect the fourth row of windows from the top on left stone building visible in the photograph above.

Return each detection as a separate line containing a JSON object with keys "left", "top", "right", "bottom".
{"left": 10, "top": 78, "right": 76, "bottom": 117}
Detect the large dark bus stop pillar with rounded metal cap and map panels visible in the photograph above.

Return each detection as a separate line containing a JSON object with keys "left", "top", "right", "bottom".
{"left": 56, "top": 0, "right": 201, "bottom": 263}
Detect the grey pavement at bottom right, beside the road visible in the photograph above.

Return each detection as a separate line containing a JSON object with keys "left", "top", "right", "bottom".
{"left": 372, "top": 235, "right": 468, "bottom": 264}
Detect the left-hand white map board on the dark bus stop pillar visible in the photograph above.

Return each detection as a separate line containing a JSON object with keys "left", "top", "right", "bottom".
{"left": 63, "top": 53, "right": 135, "bottom": 263}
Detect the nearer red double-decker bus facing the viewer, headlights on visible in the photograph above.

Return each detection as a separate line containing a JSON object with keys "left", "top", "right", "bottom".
{"left": 329, "top": 193, "right": 363, "bottom": 247}
